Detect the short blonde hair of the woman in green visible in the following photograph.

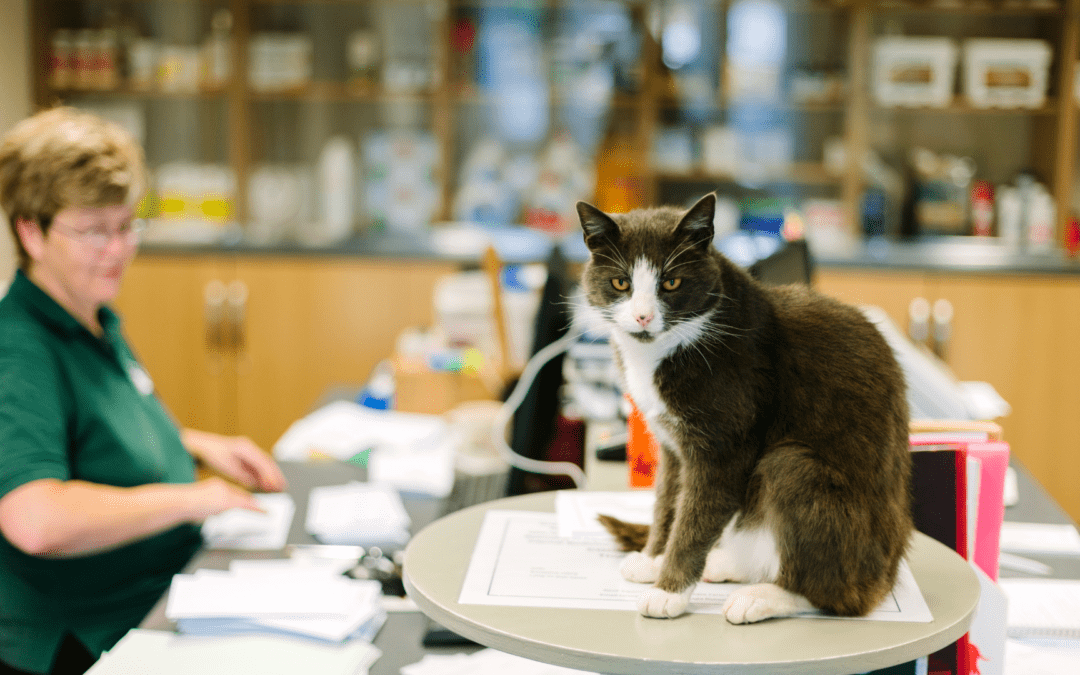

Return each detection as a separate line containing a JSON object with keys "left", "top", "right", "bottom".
{"left": 0, "top": 107, "right": 147, "bottom": 269}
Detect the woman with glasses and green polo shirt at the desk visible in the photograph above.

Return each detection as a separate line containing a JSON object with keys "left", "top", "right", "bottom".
{"left": 0, "top": 108, "right": 285, "bottom": 674}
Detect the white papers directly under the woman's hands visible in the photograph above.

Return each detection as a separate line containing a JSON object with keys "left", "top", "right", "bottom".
{"left": 202, "top": 492, "right": 296, "bottom": 550}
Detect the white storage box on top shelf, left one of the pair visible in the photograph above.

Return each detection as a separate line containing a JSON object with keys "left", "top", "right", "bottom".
{"left": 874, "top": 36, "right": 957, "bottom": 108}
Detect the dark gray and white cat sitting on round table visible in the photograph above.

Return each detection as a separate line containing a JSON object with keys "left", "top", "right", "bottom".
{"left": 578, "top": 194, "right": 912, "bottom": 623}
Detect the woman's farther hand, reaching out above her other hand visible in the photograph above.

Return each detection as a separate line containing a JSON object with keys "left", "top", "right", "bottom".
{"left": 180, "top": 429, "right": 285, "bottom": 492}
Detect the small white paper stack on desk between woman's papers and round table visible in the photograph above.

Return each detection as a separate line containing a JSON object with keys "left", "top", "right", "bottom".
{"left": 306, "top": 482, "right": 411, "bottom": 548}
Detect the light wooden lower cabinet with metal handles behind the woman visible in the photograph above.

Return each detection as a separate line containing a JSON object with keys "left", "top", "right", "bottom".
{"left": 117, "top": 254, "right": 457, "bottom": 449}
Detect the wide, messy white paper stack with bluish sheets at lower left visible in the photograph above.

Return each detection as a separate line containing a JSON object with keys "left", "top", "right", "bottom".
{"left": 165, "top": 559, "right": 386, "bottom": 643}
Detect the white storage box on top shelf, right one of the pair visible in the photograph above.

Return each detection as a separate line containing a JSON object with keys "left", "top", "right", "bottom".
{"left": 963, "top": 38, "right": 1051, "bottom": 108}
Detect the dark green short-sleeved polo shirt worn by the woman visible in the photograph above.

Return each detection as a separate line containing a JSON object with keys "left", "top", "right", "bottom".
{"left": 0, "top": 272, "right": 201, "bottom": 672}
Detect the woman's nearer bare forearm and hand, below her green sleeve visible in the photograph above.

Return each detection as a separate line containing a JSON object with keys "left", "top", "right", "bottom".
{"left": 0, "top": 477, "right": 261, "bottom": 557}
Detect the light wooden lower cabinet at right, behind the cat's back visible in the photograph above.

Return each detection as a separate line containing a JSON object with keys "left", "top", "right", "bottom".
{"left": 814, "top": 269, "right": 1080, "bottom": 519}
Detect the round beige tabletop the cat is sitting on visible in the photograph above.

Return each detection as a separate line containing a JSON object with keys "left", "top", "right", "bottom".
{"left": 404, "top": 492, "right": 980, "bottom": 675}
